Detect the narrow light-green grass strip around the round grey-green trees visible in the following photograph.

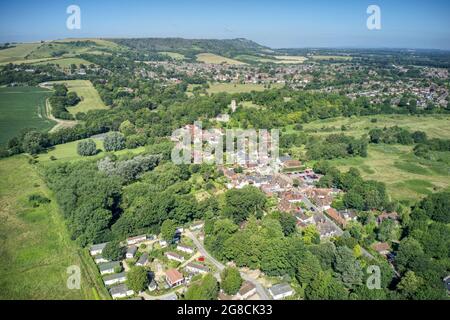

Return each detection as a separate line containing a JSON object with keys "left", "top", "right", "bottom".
{"left": 37, "top": 139, "right": 145, "bottom": 164}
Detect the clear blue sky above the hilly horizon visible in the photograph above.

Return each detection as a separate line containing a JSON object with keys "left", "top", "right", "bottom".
{"left": 0, "top": 0, "right": 450, "bottom": 49}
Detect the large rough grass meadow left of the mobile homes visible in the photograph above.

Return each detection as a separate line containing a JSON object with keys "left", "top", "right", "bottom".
{"left": 0, "top": 155, "right": 108, "bottom": 300}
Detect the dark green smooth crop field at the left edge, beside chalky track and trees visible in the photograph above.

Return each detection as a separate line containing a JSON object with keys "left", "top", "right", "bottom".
{"left": 0, "top": 87, "right": 56, "bottom": 145}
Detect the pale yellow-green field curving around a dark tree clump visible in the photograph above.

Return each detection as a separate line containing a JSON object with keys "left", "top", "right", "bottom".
{"left": 50, "top": 80, "right": 108, "bottom": 115}
